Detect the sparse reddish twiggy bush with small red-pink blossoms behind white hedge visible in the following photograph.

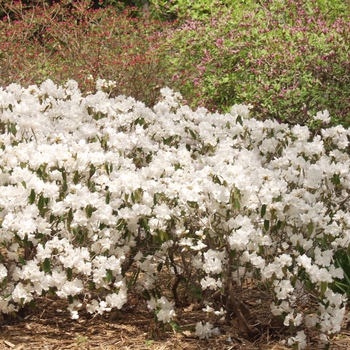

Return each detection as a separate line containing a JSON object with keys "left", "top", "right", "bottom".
{"left": 0, "top": 0, "right": 176, "bottom": 106}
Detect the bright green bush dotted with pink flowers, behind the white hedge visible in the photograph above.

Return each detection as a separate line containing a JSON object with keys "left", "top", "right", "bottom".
{"left": 163, "top": 0, "right": 350, "bottom": 126}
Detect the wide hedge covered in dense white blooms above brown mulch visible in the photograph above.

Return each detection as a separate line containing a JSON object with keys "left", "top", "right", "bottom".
{"left": 0, "top": 80, "right": 350, "bottom": 349}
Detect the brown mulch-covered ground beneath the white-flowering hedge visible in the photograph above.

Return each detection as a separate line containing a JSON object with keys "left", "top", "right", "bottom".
{"left": 0, "top": 297, "right": 350, "bottom": 350}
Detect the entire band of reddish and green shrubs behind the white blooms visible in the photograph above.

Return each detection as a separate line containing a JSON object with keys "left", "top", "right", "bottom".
{"left": 0, "top": 0, "right": 350, "bottom": 126}
